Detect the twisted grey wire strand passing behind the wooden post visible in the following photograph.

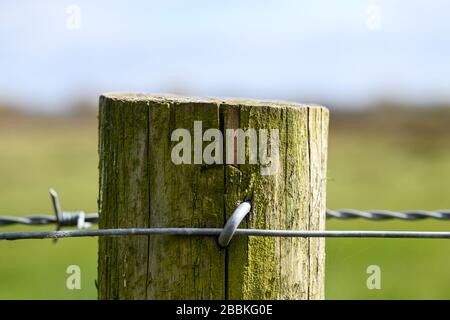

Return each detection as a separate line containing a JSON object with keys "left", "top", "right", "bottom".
{"left": 0, "top": 209, "right": 450, "bottom": 227}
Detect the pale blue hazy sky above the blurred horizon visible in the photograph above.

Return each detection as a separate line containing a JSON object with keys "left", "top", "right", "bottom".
{"left": 0, "top": 0, "right": 450, "bottom": 111}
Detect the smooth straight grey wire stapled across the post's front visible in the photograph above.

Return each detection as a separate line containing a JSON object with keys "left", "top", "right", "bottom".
{"left": 0, "top": 228, "right": 450, "bottom": 240}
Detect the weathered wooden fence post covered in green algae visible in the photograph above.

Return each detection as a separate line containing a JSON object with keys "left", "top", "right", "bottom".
{"left": 98, "top": 94, "right": 328, "bottom": 299}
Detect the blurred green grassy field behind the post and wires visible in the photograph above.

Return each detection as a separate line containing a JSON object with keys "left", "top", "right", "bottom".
{"left": 0, "top": 110, "right": 450, "bottom": 299}
